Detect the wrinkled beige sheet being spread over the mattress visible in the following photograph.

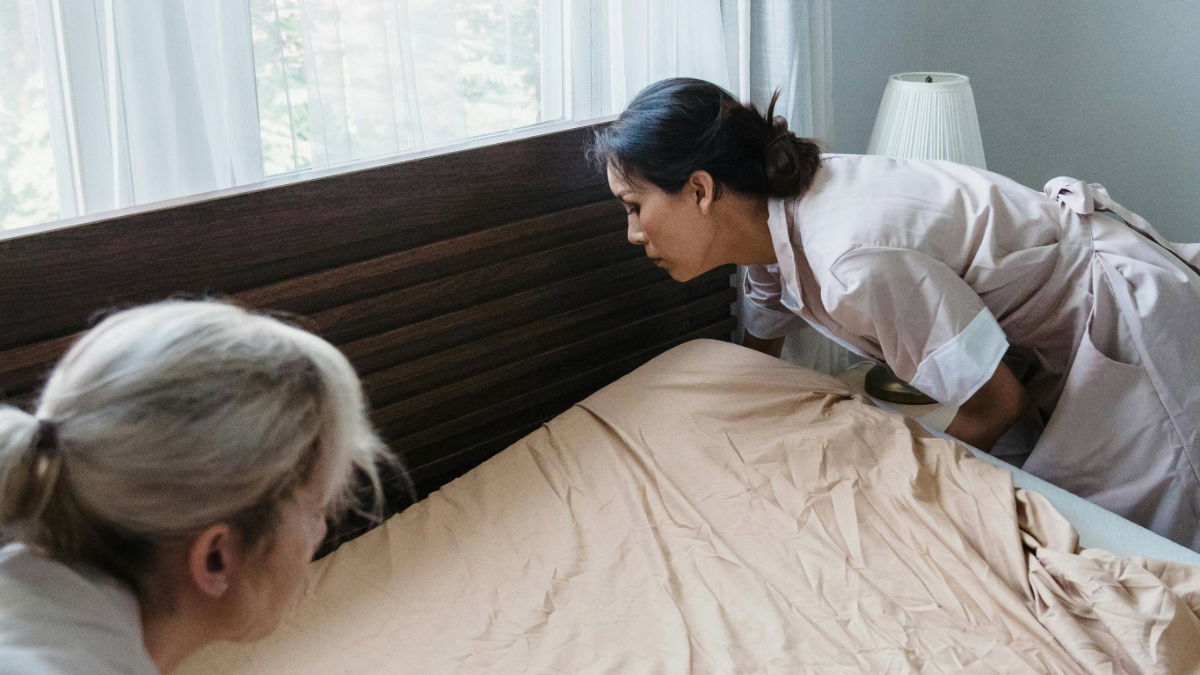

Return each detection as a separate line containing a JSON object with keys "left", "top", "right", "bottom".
{"left": 179, "top": 341, "right": 1200, "bottom": 675}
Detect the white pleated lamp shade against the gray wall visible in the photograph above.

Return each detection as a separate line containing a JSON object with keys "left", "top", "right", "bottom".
{"left": 866, "top": 72, "right": 988, "bottom": 168}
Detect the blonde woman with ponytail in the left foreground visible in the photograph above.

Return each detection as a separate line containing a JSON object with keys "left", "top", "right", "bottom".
{"left": 0, "top": 303, "right": 383, "bottom": 675}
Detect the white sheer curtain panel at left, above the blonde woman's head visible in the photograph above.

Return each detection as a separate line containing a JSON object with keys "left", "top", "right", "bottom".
{"left": 29, "top": 0, "right": 263, "bottom": 217}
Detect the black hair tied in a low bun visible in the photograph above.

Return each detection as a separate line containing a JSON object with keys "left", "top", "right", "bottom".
{"left": 589, "top": 77, "right": 821, "bottom": 198}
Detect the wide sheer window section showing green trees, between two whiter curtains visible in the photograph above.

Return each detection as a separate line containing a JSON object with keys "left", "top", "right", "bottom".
{"left": 292, "top": 0, "right": 547, "bottom": 166}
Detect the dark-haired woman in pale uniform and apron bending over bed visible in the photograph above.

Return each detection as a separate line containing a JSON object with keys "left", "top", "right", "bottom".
{"left": 592, "top": 79, "right": 1200, "bottom": 550}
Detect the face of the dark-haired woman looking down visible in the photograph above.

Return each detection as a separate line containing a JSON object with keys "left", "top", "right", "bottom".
{"left": 608, "top": 167, "right": 721, "bottom": 281}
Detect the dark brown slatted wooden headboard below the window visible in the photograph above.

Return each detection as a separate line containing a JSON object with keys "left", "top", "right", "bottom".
{"left": 0, "top": 121, "right": 734, "bottom": 509}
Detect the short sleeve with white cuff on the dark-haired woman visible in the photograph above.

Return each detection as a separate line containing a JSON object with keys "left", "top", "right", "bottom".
{"left": 821, "top": 247, "right": 1008, "bottom": 406}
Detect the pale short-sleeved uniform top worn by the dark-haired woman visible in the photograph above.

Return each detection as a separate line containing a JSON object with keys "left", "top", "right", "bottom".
{"left": 744, "top": 155, "right": 1078, "bottom": 408}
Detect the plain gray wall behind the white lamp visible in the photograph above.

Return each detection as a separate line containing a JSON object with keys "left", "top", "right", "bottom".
{"left": 832, "top": 0, "right": 1200, "bottom": 241}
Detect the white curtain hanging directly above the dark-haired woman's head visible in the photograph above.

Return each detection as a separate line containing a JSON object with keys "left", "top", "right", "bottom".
{"left": 565, "top": 0, "right": 833, "bottom": 136}
